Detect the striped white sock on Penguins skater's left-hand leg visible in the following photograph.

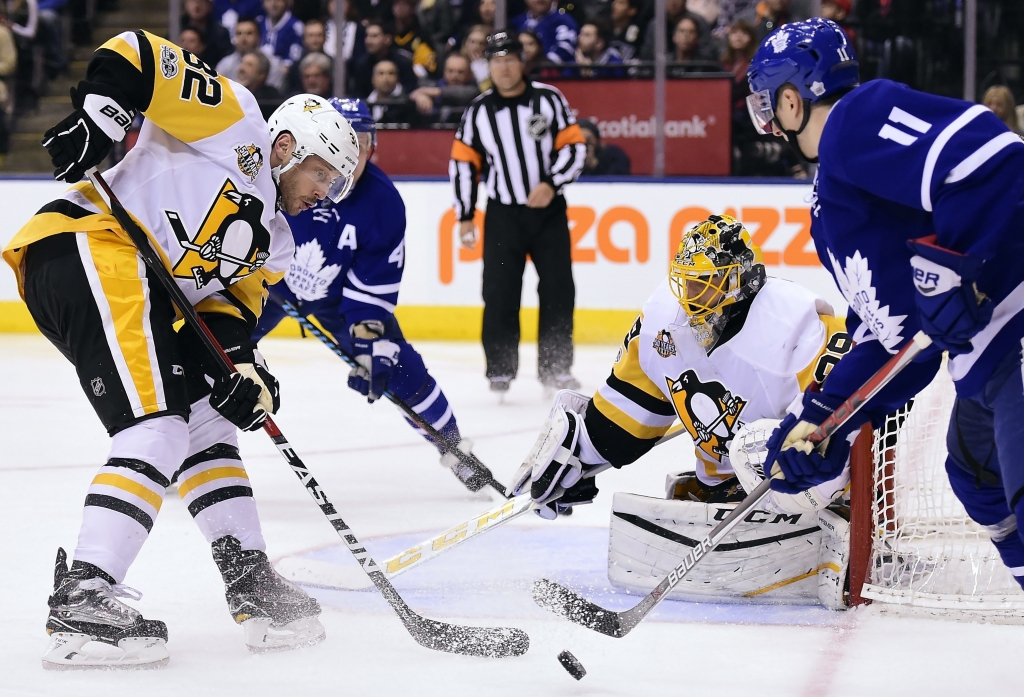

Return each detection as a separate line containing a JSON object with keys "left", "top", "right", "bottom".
{"left": 74, "top": 417, "right": 188, "bottom": 583}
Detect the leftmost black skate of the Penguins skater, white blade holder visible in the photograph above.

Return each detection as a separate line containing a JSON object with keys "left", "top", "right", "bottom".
{"left": 43, "top": 549, "right": 170, "bottom": 670}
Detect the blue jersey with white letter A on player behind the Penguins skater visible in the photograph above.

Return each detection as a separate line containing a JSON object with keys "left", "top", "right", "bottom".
{"left": 275, "top": 163, "right": 406, "bottom": 334}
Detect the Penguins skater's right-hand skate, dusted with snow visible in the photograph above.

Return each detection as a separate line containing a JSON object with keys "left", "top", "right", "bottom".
{"left": 213, "top": 535, "right": 327, "bottom": 653}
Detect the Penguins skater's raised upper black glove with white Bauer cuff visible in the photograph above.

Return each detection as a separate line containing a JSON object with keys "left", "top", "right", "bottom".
{"left": 43, "top": 85, "right": 135, "bottom": 184}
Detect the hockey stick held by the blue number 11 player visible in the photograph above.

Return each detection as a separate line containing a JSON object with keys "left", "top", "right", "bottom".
{"left": 534, "top": 332, "right": 932, "bottom": 638}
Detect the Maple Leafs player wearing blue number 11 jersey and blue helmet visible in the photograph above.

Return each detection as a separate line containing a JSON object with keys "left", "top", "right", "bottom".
{"left": 748, "top": 19, "right": 1024, "bottom": 586}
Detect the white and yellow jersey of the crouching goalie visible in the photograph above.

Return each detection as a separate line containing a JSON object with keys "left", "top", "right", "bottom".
{"left": 586, "top": 278, "right": 853, "bottom": 485}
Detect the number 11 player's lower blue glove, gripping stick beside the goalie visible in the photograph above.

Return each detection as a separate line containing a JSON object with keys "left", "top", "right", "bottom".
{"left": 764, "top": 392, "right": 854, "bottom": 493}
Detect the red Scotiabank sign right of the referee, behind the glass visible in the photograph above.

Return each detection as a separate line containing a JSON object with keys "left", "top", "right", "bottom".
{"left": 556, "top": 78, "right": 732, "bottom": 176}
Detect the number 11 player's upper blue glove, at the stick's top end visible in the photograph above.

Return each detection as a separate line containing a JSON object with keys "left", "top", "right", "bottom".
{"left": 907, "top": 235, "right": 994, "bottom": 355}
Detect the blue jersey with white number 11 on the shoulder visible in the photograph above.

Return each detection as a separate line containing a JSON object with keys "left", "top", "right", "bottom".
{"left": 811, "top": 80, "right": 1024, "bottom": 421}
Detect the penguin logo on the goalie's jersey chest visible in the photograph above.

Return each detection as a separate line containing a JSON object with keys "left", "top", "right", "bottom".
{"left": 666, "top": 371, "right": 748, "bottom": 462}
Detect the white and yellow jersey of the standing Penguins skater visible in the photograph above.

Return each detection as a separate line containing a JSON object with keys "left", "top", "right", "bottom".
{"left": 3, "top": 31, "right": 293, "bottom": 329}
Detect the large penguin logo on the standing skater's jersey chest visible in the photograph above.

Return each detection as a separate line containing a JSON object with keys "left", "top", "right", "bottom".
{"left": 164, "top": 179, "right": 270, "bottom": 291}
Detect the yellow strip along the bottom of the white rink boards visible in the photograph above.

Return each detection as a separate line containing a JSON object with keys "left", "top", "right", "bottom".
{"left": 0, "top": 300, "right": 637, "bottom": 344}
